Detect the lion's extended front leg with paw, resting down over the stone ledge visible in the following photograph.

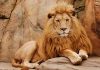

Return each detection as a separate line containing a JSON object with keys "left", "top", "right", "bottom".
{"left": 62, "top": 49, "right": 82, "bottom": 65}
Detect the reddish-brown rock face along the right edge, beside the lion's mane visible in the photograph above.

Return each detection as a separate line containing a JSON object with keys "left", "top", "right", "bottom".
{"left": 85, "top": 0, "right": 100, "bottom": 56}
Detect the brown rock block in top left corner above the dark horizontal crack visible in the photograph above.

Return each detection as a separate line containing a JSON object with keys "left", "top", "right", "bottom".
{"left": 0, "top": 0, "right": 17, "bottom": 18}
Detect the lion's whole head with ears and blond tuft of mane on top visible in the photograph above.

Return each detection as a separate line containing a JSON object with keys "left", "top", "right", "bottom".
{"left": 45, "top": 3, "right": 78, "bottom": 37}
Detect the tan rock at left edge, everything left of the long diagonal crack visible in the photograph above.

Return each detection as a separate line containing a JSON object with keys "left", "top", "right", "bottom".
{"left": 0, "top": 0, "right": 16, "bottom": 60}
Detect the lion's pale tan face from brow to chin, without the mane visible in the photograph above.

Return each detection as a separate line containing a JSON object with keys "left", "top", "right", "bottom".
{"left": 54, "top": 13, "right": 71, "bottom": 36}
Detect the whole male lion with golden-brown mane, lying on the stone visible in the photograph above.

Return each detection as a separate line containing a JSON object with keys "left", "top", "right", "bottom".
{"left": 12, "top": 3, "right": 92, "bottom": 68}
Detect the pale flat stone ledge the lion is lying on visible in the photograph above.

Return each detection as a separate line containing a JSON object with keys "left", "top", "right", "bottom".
{"left": 0, "top": 57, "right": 100, "bottom": 70}
